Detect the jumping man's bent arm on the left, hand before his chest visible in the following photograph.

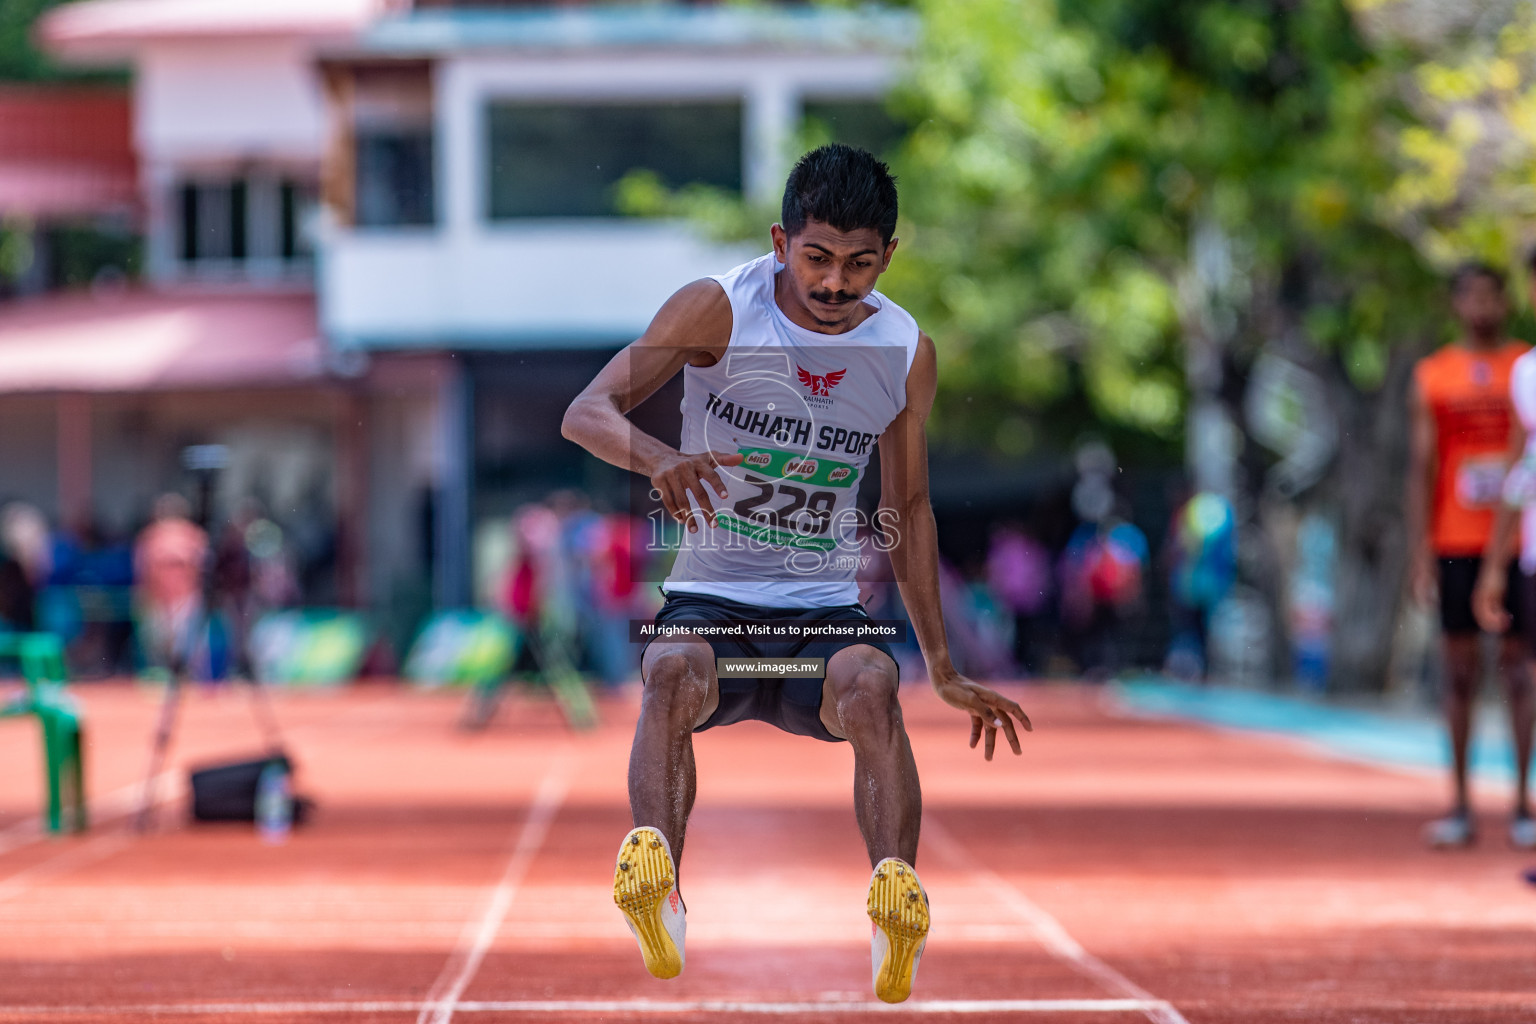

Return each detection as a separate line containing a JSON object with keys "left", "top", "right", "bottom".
{"left": 561, "top": 278, "right": 742, "bottom": 530}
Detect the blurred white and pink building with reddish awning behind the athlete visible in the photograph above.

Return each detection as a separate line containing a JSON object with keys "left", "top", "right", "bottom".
{"left": 12, "top": 0, "right": 915, "bottom": 632}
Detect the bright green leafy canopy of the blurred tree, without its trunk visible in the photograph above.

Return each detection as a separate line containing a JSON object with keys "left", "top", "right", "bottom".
{"left": 891, "top": 0, "right": 1442, "bottom": 451}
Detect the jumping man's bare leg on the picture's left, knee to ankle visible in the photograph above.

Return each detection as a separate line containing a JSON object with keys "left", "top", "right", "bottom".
{"left": 630, "top": 637, "right": 720, "bottom": 884}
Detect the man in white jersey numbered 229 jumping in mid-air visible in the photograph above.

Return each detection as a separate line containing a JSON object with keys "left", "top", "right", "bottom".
{"left": 564, "top": 144, "right": 1031, "bottom": 1003}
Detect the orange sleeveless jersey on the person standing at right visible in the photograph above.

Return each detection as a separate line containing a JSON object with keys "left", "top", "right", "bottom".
{"left": 1413, "top": 341, "right": 1530, "bottom": 557}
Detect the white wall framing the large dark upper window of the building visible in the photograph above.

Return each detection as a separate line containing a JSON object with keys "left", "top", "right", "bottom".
{"left": 318, "top": 52, "right": 897, "bottom": 347}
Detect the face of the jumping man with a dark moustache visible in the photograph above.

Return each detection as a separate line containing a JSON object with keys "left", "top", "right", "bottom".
{"left": 773, "top": 221, "right": 897, "bottom": 335}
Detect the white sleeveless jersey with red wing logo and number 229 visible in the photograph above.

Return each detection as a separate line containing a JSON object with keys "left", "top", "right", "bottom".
{"left": 662, "top": 253, "right": 919, "bottom": 608}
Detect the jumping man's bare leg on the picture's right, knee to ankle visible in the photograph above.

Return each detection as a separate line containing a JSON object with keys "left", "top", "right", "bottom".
{"left": 822, "top": 643, "right": 923, "bottom": 867}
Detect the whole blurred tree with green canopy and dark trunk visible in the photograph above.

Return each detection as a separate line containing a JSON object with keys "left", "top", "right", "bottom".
{"left": 888, "top": 0, "right": 1505, "bottom": 688}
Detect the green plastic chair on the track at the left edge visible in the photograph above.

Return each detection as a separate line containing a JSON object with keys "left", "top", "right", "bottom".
{"left": 0, "top": 633, "right": 86, "bottom": 835}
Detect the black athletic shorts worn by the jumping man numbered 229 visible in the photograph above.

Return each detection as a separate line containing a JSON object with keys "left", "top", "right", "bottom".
{"left": 638, "top": 594, "right": 895, "bottom": 743}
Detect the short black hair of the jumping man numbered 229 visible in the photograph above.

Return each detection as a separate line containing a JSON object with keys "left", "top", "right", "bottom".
{"left": 779, "top": 143, "right": 895, "bottom": 244}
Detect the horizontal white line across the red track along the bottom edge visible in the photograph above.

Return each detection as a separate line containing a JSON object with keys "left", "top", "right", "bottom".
{"left": 0, "top": 999, "right": 1167, "bottom": 1019}
